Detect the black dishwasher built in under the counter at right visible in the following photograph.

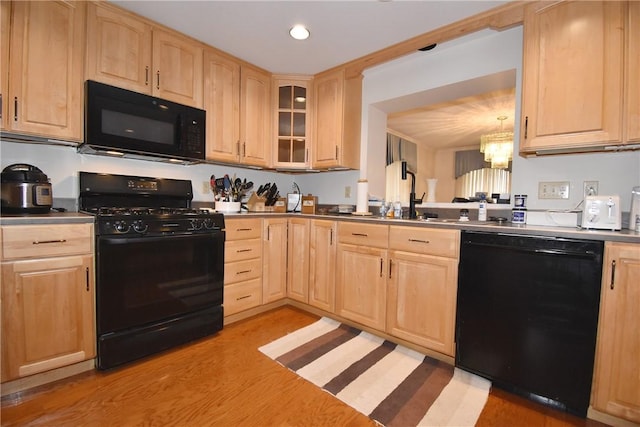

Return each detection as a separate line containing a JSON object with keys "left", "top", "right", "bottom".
{"left": 456, "top": 231, "right": 604, "bottom": 417}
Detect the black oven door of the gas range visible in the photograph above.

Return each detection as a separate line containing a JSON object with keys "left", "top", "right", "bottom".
{"left": 96, "top": 232, "right": 224, "bottom": 335}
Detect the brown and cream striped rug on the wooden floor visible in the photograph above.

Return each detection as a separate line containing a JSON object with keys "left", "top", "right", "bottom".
{"left": 259, "top": 317, "right": 491, "bottom": 426}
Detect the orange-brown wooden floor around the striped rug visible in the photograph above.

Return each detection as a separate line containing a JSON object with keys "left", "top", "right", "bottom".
{"left": 1, "top": 307, "right": 603, "bottom": 427}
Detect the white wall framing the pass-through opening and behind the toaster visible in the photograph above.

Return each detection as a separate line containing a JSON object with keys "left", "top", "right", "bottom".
{"left": 361, "top": 27, "right": 640, "bottom": 211}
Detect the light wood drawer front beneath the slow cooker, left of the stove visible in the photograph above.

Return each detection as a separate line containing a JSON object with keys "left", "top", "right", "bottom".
{"left": 2, "top": 224, "right": 93, "bottom": 259}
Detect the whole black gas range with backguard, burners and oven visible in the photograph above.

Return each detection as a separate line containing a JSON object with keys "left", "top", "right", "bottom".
{"left": 79, "top": 172, "right": 225, "bottom": 369}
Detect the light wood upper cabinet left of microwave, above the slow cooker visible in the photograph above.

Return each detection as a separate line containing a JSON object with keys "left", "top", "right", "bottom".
{"left": 2, "top": 1, "right": 85, "bottom": 141}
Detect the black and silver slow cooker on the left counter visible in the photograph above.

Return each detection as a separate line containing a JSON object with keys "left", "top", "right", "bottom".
{"left": 0, "top": 163, "right": 53, "bottom": 214}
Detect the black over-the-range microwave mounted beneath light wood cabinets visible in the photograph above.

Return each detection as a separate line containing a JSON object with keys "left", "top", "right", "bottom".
{"left": 78, "top": 80, "right": 206, "bottom": 162}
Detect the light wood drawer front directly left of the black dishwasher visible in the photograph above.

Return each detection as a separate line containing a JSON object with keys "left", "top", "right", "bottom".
{"left": 389, "top": 226, "right": 460, "bottom": 258}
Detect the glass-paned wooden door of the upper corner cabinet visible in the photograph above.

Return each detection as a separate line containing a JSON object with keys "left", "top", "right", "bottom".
{"left": 275, "top": 81, "right": 310, "bottom": 167}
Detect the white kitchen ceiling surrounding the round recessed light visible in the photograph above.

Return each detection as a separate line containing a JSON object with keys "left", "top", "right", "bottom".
{"left": 111, "top": 0, "right": 507, "bottom": 75}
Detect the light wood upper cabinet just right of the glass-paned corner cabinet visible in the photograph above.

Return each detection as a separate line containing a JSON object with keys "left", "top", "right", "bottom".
{"left": 312, "top": 69, "right": 362, "bottom": 169}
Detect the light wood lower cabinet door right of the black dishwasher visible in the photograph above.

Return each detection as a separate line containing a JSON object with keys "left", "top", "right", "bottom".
{"left": 591, "top": 242, "right": 640, "bottom": 423}
